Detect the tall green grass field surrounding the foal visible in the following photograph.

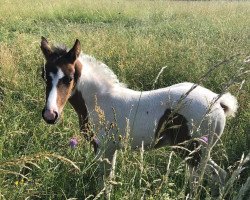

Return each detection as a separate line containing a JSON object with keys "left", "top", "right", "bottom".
{"left": 0, "top": 0, "right": 250, "bottom": 200}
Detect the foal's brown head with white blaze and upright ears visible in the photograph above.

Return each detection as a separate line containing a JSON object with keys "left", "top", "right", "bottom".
{"left": 41, "top": 37, "right": 81, "bottom": 124}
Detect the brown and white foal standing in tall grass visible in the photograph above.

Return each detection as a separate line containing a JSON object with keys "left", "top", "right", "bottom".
{"left": 41, "top": 37, "right": 237, "bottom": 192}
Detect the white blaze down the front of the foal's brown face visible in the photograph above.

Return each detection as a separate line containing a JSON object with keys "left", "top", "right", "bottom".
{"left": 47, "top": 68, "right": 64, "bottom": 112}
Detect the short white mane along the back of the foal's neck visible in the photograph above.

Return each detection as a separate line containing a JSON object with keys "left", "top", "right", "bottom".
{"left": 80, "top": 53, "right": 126, "bottom": 87}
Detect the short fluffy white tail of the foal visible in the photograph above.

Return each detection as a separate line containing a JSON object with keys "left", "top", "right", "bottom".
{"left": 219, "top": 93, "right": 238, "bottom": 117}
